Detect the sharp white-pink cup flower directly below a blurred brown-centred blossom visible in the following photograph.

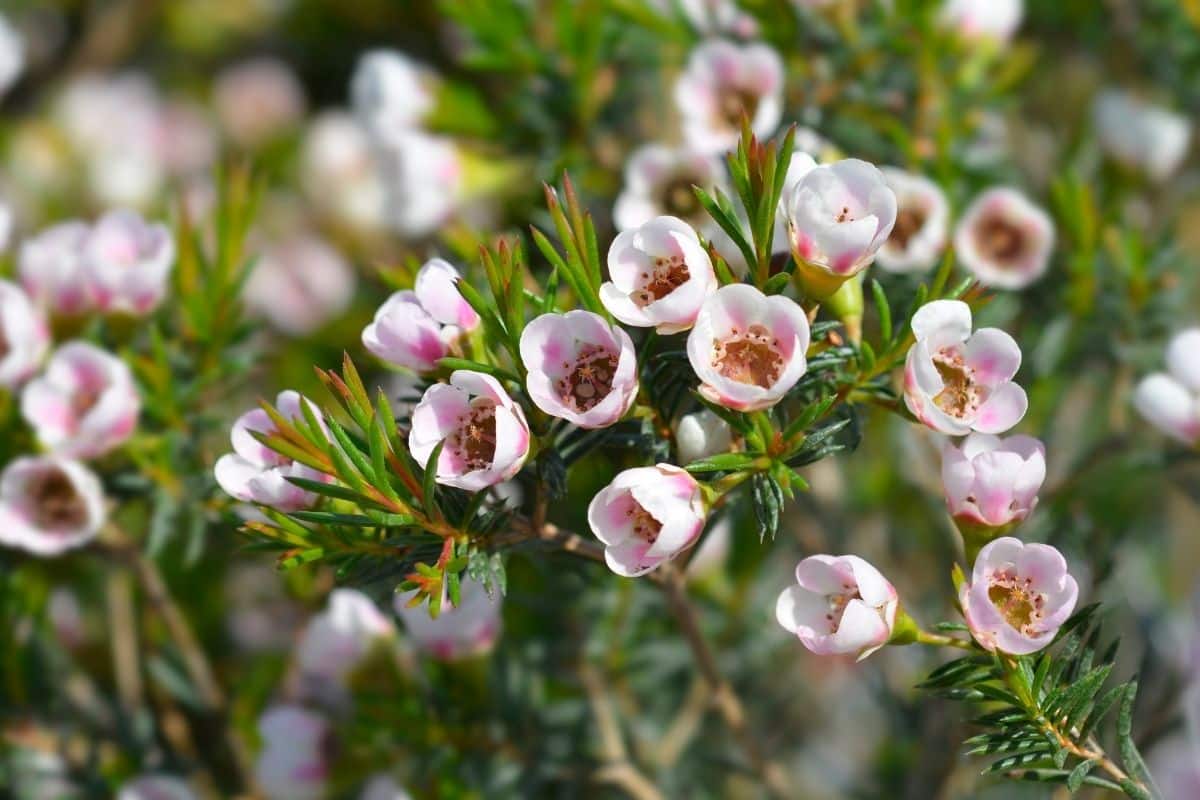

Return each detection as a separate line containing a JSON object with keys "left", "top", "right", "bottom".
{"left": 600, "top": 217, "right": 716, "bottom": 333}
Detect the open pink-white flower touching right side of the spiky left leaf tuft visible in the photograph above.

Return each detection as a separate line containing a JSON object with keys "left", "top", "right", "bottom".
{"left": 408, "top": 369, "right": 529, "bottom": 492}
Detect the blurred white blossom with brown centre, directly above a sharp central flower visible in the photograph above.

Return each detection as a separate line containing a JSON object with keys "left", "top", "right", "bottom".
{"left": 612, "top": 144, "right": 725, "bottom": 234}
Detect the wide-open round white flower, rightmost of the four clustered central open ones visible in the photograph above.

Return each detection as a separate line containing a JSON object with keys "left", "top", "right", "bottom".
{"left": 688, "top": 283, "right": 809, "bottom": 411}
